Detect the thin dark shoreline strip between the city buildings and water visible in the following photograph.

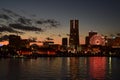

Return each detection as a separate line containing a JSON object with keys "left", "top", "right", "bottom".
{"left": 0, "top": 53, "right": 120, "bottom": 59}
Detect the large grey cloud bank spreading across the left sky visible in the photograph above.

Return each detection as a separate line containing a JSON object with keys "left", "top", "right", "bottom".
{"left": 0, "top": 8, "right": 60, "bottom": 33}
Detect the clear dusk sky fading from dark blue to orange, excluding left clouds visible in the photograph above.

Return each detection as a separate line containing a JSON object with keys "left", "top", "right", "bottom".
{"left": 0, "top": 0, "right": 120, "bottom": 43}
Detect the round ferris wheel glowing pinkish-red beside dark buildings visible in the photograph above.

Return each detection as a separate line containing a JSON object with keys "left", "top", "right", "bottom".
{"left": 90, "top": 34, "right": 105, "bottom": 46}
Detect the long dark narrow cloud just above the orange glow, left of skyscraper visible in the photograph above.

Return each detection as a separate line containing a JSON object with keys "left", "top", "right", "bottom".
{"left": 9, "top": 24, "right": 42, "bottom": 31}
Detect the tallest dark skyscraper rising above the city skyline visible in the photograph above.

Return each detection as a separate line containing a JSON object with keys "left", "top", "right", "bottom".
{"left": 69, "top": 20, "right": 79, "bottom": 49}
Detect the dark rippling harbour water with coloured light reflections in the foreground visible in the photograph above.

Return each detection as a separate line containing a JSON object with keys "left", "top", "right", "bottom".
{"left": 0, "top": 57, "right": 120, "bottom": 80}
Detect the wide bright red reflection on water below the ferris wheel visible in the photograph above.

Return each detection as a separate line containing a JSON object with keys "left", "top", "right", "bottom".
{"left": 89, "top": 57, "right": 107, "bottom": 80}
